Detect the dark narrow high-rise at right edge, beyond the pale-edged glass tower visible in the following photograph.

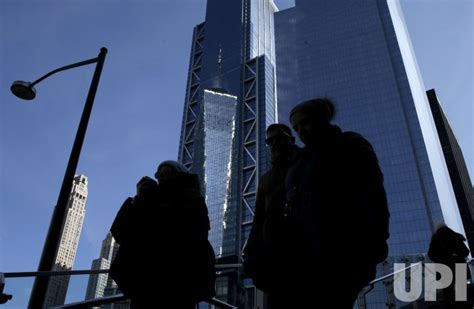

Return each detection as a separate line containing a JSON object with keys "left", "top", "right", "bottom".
{"left": 426, "top": 89, "right": 474, "bottom": 249}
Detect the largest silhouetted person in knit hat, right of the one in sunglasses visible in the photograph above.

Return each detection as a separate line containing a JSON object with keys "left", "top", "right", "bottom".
{"left": 281, "top": 98, "right": 389, "bottom": 308}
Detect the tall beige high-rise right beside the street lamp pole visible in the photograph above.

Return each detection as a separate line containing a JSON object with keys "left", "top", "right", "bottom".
{"left": 44, "top": 175, "right": 87, "bottom": 308}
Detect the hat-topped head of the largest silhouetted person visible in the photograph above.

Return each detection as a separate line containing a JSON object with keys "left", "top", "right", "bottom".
{"left": 290, "top": 98, "right": 335, "bottom": 146}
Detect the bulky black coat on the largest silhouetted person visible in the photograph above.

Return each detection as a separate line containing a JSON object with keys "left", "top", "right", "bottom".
{"left": 286, "top": 125, "right": 389, "bottom": 288}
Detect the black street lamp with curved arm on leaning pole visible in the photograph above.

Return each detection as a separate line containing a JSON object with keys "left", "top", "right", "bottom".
{"left": 10, "top": 47, "right": 107, "bottom": 309}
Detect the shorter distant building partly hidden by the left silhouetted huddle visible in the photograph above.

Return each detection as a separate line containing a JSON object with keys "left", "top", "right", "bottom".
{"left": 85, "top": 232, "right": 119, "bottom": 300}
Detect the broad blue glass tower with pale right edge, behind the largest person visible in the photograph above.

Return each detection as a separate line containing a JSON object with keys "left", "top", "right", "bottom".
{"left": 275, "top": 0, "right": 465, "bottom": 308}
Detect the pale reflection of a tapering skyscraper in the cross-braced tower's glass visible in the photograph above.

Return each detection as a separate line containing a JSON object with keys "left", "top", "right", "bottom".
{"left": 199, "top": 89, "right": 237, "bottom": 256}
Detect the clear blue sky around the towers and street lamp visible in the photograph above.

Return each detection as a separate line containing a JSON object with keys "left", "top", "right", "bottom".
{"left": 0, "top": 0, "right": 474, "bottom": 308}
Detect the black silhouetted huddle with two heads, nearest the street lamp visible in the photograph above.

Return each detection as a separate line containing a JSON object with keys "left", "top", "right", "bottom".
{"left": 111, "top": 161, "right": 215, "bottom": 309}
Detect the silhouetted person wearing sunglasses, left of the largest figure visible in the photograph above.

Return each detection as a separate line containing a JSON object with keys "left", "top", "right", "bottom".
{"left": 244, "top": 124, "right": 299, "bottom": 298}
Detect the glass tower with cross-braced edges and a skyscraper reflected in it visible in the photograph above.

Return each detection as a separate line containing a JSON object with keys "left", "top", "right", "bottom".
{"left": 178, "top": 0, "right": 277, "bottom": 308}
